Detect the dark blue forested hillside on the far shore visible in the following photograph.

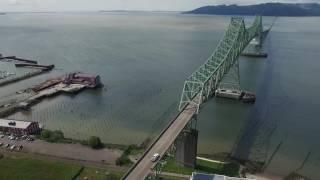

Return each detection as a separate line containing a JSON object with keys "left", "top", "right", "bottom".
{"left": 184, "top": 3, "right": 320, "bottom": 16}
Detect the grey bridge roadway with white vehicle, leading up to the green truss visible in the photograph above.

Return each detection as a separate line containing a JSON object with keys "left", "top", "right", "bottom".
{"left": 123, "top": 104, "right": 197, "bottom": 180}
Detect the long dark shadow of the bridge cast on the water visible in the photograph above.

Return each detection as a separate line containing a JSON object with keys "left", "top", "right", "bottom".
{"left": 231, "top": 40, "right": 277, "bottom": 171}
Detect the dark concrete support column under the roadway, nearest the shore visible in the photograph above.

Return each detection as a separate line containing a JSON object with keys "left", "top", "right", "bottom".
{"left": 175, "top": 129, "right": 198, "bottom": 168}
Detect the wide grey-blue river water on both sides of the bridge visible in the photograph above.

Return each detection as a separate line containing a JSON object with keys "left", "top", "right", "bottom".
{"left": 0, "top": 13, "right": 320, "bottom": 179}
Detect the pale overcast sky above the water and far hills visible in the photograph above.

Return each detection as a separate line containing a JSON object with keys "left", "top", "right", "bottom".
{"left": 0, "top": 0, "right": 320, "bottom": 11}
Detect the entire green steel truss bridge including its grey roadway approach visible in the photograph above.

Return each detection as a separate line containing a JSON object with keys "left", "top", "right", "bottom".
{"left": 123, "top": 16, "right": 272, "bottom": 180}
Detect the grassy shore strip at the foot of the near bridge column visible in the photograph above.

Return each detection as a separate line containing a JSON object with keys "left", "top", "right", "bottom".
{"left": 163, "top": 158, "right": 239, "bottom": 177}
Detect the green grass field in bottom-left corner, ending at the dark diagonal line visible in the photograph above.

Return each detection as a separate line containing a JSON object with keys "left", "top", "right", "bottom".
{"left": 0, "top": 157, "right": 81, "bottom": 180}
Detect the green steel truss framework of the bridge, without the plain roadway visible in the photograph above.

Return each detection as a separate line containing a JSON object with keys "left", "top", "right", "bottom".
{"left": 179, "top": 16, "right": 264, "bottom": 112}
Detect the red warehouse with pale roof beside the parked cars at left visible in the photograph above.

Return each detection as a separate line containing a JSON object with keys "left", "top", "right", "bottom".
{"left": 0, "top": 119, "right": 40, "bottom": 135}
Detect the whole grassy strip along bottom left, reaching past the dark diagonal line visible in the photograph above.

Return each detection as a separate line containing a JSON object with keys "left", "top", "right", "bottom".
{"left": 0, "top": 157, "right": 122, "bottom": 180}
